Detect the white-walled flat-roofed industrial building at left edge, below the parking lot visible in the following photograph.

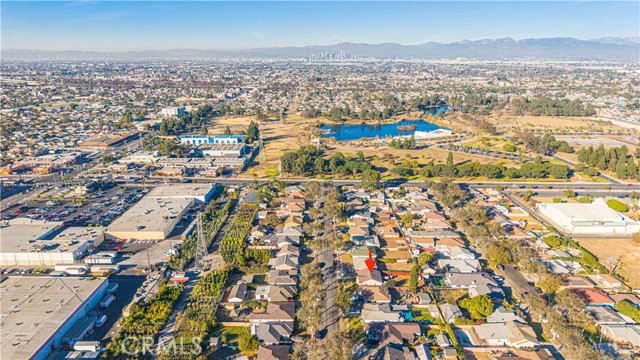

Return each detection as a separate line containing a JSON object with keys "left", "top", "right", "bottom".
{"left": 0, "top": 218, "right": 104, "bottom": 266}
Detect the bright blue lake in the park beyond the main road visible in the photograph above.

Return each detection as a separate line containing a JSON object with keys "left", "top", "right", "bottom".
{"left": 320, "top": 120, "right": 440, "bottom": 141}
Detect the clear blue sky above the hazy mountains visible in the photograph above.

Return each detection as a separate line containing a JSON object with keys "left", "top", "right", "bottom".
{"left": 0, "top": 0, "right": 640, "bottom": 51}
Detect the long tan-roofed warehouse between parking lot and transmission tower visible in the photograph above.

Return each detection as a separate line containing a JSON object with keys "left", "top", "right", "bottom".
{"left": 107, "top": 184, "right": 215, "bottom": 240}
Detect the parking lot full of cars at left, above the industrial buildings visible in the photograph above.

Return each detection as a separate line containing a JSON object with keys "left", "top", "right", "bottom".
{"left": 2, "top": 185, "right": 149, "bottom": 226}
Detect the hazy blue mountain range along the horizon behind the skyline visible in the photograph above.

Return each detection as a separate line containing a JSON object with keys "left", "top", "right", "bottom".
{"left": 0, "top": 37, "right": 640, "bottom": 62}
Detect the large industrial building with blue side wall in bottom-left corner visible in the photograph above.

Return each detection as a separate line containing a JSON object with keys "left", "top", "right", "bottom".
{"left": 0, "top": 276, "right": 109, "bottom": 360}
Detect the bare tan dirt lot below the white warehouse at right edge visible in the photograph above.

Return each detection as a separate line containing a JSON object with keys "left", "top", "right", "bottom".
{"left": 576, "top": 239, "right": 640, "bottom": 288}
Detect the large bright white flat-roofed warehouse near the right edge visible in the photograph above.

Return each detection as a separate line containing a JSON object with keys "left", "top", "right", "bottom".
{"left": 537, "top": 202, "right": 640, "bottom": 235}
